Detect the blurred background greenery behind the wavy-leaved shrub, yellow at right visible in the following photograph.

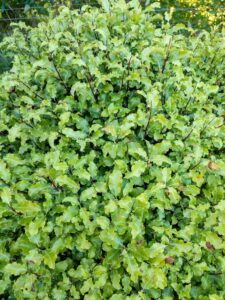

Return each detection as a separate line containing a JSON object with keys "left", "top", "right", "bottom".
{"left": 0, "top": 0, "right": 225, "bottom": 74}
